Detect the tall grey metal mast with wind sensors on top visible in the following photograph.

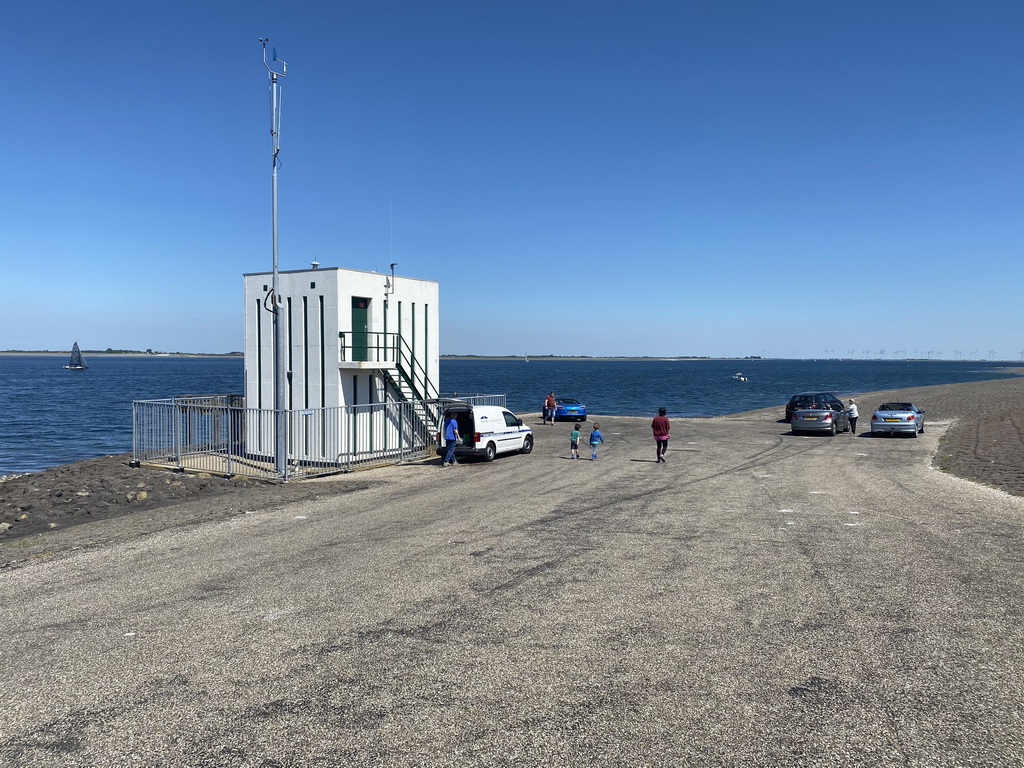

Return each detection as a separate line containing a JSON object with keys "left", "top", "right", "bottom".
{"left": 260, "top": 37, "right": 288, "bottom": 481}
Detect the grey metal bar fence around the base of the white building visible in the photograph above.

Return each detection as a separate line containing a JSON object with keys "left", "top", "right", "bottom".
{"left": 132, "top": 395, "right": 505, "bottom": 480}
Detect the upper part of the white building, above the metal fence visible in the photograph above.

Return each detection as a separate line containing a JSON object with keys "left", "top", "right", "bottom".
{"left": 245, "top": 267, "right": 440, "bottom": 410}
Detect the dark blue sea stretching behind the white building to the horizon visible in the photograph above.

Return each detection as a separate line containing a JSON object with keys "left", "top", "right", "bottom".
{"left": 0, "top": 355, "right": 1019, "bottom": 475}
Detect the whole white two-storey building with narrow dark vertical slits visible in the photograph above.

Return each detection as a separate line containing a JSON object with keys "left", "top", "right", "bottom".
{"left": 244, "top": 267, "right": 440, "bottom": 472}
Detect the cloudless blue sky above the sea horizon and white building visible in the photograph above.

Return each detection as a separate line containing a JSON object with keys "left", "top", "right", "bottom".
{"left": 8, "top": 0, "right": 1024, "bottom": 360}
